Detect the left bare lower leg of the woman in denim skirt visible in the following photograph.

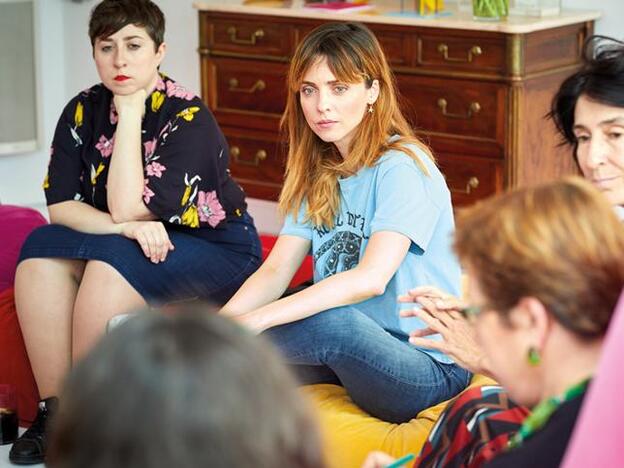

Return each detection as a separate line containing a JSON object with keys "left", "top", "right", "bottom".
{"left": 15, "top": 258, "right": 85, "bottom": 398}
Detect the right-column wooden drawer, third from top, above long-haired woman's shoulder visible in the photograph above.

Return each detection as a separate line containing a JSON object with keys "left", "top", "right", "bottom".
{"left": 436, "top": 154, "right": 504, "bottom": 207}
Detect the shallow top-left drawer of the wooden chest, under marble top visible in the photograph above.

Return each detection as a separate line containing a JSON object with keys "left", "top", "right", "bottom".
{"left": 200, "top": 13, "right": 295, "bottom": 59}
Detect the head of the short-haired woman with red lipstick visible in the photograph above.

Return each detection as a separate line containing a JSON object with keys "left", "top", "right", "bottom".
{"left": 89, "top": 0, "right": 166, "bottom": 95}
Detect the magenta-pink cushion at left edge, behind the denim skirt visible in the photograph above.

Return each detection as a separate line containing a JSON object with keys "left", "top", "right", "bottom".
{"left": 0, "top": 205, "right": 46, "bottom": 291}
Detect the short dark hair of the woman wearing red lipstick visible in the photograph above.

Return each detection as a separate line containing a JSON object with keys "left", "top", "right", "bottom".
{"left": 89, "top": 0, "right": 165, "bottom": 49}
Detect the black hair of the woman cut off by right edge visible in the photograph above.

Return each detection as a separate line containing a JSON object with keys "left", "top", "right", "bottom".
{"left": 548, "top": 36, "right": 624, "bottom": 157}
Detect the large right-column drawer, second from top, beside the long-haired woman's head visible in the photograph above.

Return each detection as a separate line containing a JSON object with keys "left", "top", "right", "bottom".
{"left": 397, "top": 74, "right": 507, "bottom": 145}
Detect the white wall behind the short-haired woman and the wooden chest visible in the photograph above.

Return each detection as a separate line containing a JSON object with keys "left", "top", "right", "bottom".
{"left": 0, "top": 0, "right": 624, "bottom": 232}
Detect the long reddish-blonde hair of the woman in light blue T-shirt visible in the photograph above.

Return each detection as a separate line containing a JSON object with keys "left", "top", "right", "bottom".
{"left": 279, "top": 23, "right": 434, "bottom": 228}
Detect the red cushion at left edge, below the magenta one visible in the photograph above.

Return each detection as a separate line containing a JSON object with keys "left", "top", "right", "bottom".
{"left": 0, "top": 288, "right": 39, "bottom": 426}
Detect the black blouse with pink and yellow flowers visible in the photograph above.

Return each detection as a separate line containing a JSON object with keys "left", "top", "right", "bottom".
{"left": 43, "top": 75, "right": 247, "bottom": 239}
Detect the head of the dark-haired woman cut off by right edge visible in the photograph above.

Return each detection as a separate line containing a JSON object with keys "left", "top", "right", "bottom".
{"left": 550, "top": 36, "right": 624, "bottom": 205}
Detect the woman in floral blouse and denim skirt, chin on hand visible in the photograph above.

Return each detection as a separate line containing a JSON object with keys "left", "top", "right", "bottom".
{"left": 10, "top": 0, "right": 261, "bottom": 464}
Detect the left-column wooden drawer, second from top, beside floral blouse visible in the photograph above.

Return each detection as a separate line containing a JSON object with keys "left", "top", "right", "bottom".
{"left": 206, "top": 57, "right": 288, "bottom": 130}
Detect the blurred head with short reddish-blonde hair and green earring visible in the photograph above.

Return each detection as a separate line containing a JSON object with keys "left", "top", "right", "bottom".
{"left": 455, "top": 177, "right": 624, "bottom": 406}
